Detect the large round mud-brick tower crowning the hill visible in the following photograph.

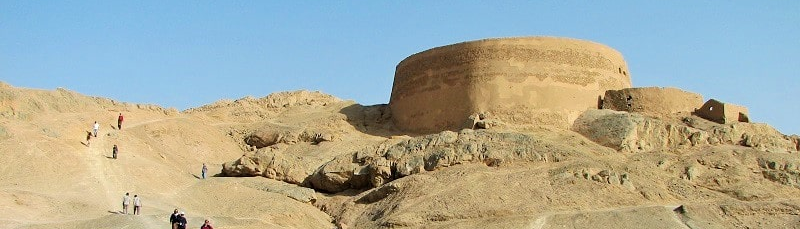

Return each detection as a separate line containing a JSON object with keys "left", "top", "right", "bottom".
{"left": 389, "top": 37, "right": 631, "bottom": 132}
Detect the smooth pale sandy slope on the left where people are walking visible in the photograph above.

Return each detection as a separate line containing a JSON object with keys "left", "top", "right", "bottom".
{"left": 0, "top": 83, "right": 331, "bottom": 228}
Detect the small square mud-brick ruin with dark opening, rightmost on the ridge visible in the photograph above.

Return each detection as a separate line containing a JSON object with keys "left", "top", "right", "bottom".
{"left": 695, "top": 99, "right": 750, "bottom": 124}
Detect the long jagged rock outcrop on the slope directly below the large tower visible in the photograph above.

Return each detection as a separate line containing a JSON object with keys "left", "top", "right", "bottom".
{"left": 309, "top": 129, "right": 592, "bottom": 192}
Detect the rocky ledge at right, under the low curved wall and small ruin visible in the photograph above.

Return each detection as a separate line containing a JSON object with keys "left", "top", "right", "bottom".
{"left": 572, "top": 110, "right": 798, "bottom": 152}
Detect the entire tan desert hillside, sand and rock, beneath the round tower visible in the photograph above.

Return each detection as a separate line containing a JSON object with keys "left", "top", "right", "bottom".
{"left": 0, "top": 81, "right": 800, "bottom": 228}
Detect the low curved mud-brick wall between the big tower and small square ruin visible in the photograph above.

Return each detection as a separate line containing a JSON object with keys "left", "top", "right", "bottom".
{"left": 602, "top": 87, "right": 703, "bottom": 117}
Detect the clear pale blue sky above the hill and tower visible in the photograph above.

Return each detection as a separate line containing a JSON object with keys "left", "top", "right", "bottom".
{"left": 0, "top": 0, "right": 800, "bottom": 134}
